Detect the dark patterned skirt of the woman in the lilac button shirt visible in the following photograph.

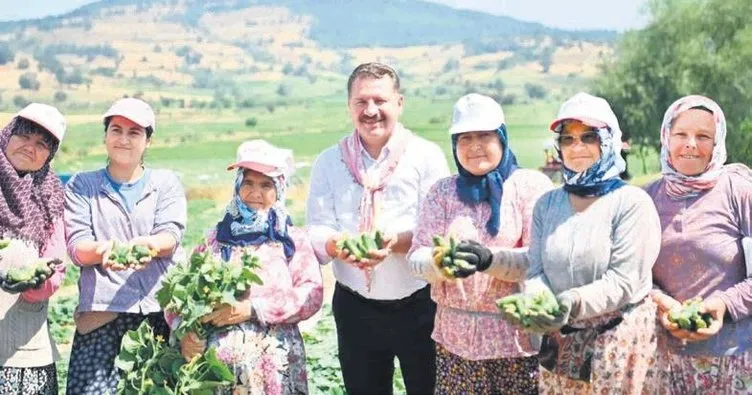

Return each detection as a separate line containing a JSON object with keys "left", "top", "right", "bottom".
{"left": 66, "top": 312, "right": 170, "bottom": 395}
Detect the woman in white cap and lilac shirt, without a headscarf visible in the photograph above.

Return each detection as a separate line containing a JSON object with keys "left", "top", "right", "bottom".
{"left": 65, "top": 98, "right": 187, "bottom": 394}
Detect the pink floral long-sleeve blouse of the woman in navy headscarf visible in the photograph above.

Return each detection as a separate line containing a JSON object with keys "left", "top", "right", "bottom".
{"left": 408, "top": 169, "right": 553, "bottom": 360}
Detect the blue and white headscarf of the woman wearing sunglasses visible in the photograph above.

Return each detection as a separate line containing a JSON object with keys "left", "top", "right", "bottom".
{"left": 556, "top": 125, "right": 627, "bottom": 197}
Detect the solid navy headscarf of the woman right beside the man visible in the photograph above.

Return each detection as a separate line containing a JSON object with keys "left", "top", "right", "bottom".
{"left": 452, "top": 124, "right": 517, "bottom": 236}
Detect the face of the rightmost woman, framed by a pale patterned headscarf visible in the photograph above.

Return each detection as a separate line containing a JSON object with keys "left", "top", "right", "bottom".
{"left": 668, "top": 109, "right": 716, "bottom": 176}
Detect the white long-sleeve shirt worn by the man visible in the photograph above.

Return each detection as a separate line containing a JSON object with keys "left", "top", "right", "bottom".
{"left": 307, "top": 136, "right": 449, "bottom": 300}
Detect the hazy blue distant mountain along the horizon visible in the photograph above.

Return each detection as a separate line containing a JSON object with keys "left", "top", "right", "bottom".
{"left": 0, "top": 0, "right": 616, "bottom": 53}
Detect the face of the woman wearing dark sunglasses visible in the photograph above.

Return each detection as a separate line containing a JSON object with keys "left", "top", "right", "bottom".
{"left": 557, "top": 120, "right": 601, "bottom": 173}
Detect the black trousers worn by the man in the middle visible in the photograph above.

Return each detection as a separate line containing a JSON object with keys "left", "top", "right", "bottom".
{"left": 332, "top": 283, "right": 436, "bottom": 395}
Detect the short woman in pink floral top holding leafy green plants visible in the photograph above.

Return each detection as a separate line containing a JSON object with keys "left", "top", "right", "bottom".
{"left": 181, "top": 140, "right": 323, "bottom": 394}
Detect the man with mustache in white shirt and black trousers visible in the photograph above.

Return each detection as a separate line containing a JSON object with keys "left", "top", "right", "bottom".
{"left": 307, "top": 63, "right": 449, "bottom": 395}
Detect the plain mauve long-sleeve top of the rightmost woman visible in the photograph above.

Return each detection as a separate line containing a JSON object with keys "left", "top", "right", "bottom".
{"left": 646, "top": 173, "right": 752, "bottom": 356}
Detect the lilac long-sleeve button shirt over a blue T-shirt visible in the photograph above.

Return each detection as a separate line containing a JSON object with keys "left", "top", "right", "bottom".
{"left": 65, "top": 169, "right": 187, "bottom": 314}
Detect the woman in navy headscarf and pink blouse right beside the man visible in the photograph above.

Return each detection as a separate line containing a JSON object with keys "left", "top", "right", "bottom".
{"left": 409, "top": 93, "right": 553, "bottom": 394}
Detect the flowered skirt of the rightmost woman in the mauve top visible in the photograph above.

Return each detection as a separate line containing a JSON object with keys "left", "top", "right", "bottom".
{"left": 661, "top": 351, "right": 752, "bottom": 395}
